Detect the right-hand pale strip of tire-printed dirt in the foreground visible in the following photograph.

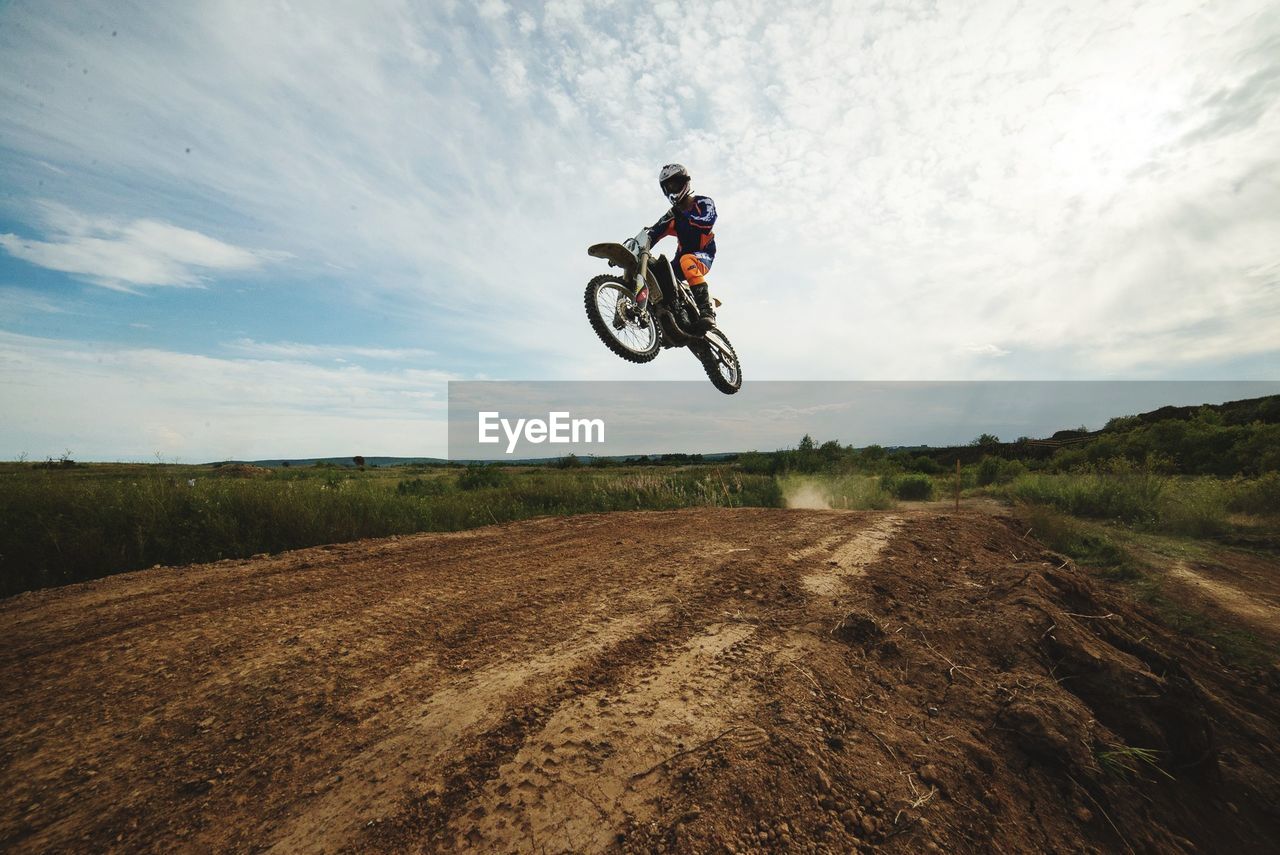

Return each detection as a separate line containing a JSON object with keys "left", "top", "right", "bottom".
{"left": 452, "top": 623, "right": 763, "bottom": 851}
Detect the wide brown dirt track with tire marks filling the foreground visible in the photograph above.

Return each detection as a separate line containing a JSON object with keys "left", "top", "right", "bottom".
{"left": 0, "top": 509, "right": 1280, "bottom": 852}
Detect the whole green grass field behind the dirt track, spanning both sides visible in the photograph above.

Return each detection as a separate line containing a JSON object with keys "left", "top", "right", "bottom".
{"left": 0, "top": 459, "right": 1280, "bottom": 611}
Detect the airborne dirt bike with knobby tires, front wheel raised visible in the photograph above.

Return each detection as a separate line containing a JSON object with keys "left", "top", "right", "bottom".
{"left": 584, "top": 243, "right": 742, "bottom": 394}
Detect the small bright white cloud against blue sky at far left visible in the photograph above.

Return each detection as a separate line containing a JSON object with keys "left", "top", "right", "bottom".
{"left": 0, "top": 204, "right": 280, "bottom": 291}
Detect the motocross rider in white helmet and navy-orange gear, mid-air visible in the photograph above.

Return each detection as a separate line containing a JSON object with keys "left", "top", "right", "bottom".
{"left": 626, "top": 164, "right": 716, "bottom": 330}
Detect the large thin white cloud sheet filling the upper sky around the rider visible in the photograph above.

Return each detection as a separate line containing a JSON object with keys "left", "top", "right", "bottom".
{"left": 0, "top": 0, "right": 1280, "bottom": 396}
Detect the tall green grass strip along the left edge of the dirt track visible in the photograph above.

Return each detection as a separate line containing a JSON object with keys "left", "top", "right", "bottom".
{"left": 0, "top": 467, "right": 782, "bottom": 595}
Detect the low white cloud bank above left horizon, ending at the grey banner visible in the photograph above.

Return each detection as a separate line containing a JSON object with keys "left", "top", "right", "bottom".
{"left": 0, "top": 332, "right": 456, "bottom": 462}
